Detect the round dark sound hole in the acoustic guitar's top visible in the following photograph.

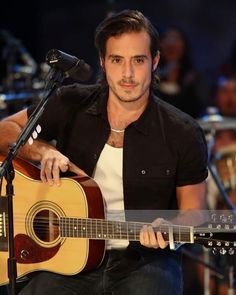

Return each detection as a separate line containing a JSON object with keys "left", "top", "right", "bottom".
{"left": 33, "top": 210, "right": 59, "bottom": 242}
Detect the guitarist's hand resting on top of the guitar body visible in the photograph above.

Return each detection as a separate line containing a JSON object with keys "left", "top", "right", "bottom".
{"left": 40, "top": 148, "right": 87, "bottom": 186}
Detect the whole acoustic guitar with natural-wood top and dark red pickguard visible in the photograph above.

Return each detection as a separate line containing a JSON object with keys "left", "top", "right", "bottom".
{"left": 0, "top": 156, "right": 236, "bottom": 285}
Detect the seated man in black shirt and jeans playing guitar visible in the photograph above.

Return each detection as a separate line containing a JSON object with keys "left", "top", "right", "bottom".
{"left": 0, "top": 10, "right": 207, "bottom": 295}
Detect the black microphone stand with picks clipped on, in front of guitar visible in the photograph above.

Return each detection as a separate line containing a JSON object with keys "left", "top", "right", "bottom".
{"left": 0, "top": 68, "right": 65, "bottom": 295}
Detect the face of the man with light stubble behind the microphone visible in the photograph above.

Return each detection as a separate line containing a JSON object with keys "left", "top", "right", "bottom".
{"left": 101, "top": 31, "right": 159, "bottom": 102}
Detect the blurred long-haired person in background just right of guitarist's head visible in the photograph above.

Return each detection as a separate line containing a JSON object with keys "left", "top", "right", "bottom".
{"left": 156, "top": 27, "right": 208, "bottom": 118}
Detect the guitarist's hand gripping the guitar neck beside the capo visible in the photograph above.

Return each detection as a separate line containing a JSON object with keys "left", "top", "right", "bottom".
{"left": 139, "top": 218, "right": 169, "bottom": 249}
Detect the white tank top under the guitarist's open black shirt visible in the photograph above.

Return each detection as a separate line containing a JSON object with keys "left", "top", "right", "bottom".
{"left": 93, "top": 144, "right": 129, "bottom": 249}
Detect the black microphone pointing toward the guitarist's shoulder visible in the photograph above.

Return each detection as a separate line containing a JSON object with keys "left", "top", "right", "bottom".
{"left": 46, "top": 49, "right": 92, "bottom": 81}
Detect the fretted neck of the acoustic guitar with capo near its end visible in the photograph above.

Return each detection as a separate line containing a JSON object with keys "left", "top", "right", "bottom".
{"left": 59, "top": 217, "right": 193, "bottom": 243}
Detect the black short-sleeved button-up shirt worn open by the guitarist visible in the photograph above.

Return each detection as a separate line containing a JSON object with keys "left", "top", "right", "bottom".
{"left": 28, "top": 84, "right": 207, "bottom": 215}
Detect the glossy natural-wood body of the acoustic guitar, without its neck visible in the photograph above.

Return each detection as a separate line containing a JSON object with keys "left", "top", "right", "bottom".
{"left": 0, "top": 156, "right": 105, "bottom": 285}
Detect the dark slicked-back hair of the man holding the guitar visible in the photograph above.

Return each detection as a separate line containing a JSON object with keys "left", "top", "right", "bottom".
{"left": 95, "top": 9, "right": 159, "bottom": 58}
